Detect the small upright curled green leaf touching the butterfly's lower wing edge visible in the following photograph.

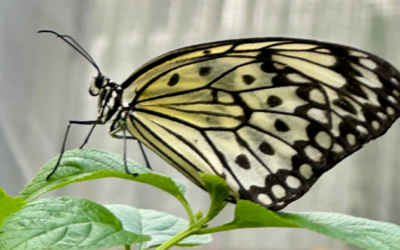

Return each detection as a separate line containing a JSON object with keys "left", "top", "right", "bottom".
{"left": 200, "top": 173, "right": 229, "bottom": 219}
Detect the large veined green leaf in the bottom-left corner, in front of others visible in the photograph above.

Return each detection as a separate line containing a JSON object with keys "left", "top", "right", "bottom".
{"left": 0, "top": 197, "right": 150, "bottom": 250}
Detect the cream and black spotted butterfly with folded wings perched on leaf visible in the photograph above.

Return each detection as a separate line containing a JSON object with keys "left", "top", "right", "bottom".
{"left": 42, "top": 31, "right": 400, "bottom": 211}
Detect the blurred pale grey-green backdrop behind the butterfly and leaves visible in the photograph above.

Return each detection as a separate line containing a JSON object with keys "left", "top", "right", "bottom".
{"left": 0, "top": 0, "right": 400, "bottom": 250}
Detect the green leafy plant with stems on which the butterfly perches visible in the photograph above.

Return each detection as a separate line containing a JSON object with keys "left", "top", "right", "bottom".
{"left": 0, "top": 149, "right": 400, "bottom": 250}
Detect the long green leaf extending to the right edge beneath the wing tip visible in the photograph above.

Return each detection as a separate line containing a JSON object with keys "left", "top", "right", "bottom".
{"left": 200, "top": 200, "right": 400, "bottom": 250}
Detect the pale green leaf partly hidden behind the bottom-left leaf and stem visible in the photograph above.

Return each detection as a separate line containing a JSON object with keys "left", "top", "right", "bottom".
{"left": 105, "top": 205, "right": 212, "bottom": 249}
